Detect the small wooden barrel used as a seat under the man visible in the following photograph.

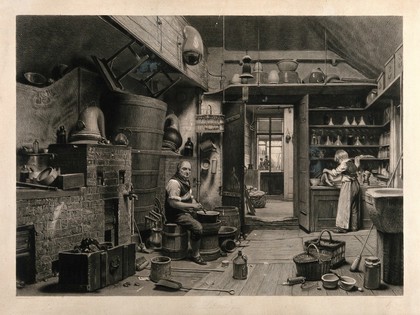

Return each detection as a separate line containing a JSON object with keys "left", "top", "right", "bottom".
{"left": 162, "top": 223, "right": 188, "bottom": 260}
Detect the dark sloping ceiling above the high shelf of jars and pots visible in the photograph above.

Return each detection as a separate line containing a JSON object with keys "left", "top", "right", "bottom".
{"left": 186, "top": 16, "right": 403, "bottom": 78}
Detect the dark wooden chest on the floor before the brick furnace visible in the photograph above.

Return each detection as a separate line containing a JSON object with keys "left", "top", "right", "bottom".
{"left": 59, "top": 243, "right": 136, "bottom": 292}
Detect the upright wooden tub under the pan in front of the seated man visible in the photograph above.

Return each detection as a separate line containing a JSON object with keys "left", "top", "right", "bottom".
{"left": 200, "top": 220, "right": 222, "bottom": 261}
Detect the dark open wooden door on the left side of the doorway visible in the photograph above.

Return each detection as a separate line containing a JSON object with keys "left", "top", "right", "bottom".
{"left": 222, "top": 103, "right": 245, "bottom": 235}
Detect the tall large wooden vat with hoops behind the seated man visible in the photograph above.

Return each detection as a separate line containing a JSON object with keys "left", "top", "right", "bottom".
{"left": 104, "top": 92, "right": 167, "bottom": 230}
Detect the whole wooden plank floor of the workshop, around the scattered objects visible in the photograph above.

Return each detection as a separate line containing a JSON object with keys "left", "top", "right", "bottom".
{"left": 17, "top": 229, "right": 404, "bottom": 297}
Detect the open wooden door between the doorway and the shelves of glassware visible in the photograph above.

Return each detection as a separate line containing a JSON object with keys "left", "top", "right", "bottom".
{"left": 293, "top": 95, "right": 310, "bottom": 231}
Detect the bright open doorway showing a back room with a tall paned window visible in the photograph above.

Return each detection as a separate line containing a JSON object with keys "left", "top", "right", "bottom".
{"left": 244, "top": 104, "right": 293, "bottom": 223}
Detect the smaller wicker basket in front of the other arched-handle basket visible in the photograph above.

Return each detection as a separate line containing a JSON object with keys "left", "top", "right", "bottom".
{"left": 293, "top": 244, "right": 331, "bottom": 281}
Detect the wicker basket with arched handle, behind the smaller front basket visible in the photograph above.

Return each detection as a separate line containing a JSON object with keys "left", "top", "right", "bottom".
{"left": 304, "top": 230, "right": 346, "bottom": 268}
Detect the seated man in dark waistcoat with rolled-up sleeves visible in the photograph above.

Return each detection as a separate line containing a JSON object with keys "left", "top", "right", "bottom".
{"left": 165, "top": 161, "right": 207, "bottom": 265}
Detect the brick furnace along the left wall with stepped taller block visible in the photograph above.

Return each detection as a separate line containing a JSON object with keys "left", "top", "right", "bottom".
{"left": 17, "top": 144, "right": 131, "bottom": 281}
